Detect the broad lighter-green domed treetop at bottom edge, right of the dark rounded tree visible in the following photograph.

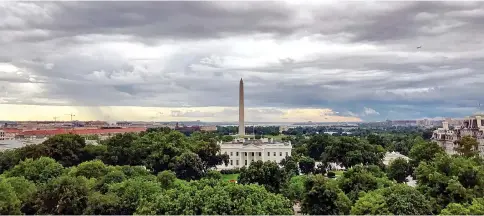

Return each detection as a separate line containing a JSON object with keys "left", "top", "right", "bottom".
{"left": 351, "top": 184, "right": 432, "bottom": 215}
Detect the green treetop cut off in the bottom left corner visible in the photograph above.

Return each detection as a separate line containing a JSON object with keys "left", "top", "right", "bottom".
{"left": 0, "top": 179, "right": 21, "bottom": 215}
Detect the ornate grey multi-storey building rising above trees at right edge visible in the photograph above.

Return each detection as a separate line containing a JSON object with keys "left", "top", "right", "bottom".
{"left": 431, "top": 114, "right": 484, "bottom": 156}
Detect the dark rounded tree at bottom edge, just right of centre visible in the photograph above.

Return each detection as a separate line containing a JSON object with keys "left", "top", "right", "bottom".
{"left": 301, "top": 175, "right": 351, "bottom": 215}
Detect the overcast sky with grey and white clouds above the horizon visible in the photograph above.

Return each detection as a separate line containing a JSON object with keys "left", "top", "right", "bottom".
{"left": 0, "top": 1, "right": 484, "bottom": 121}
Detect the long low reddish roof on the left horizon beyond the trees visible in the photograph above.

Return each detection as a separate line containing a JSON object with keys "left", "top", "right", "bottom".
{"left": 19, "top": 127, "right": 146, "bottom": 136}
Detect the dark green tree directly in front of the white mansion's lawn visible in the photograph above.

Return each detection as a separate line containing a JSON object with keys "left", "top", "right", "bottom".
{"left": 238, "top": 161, "right": 287, "bottom": 193}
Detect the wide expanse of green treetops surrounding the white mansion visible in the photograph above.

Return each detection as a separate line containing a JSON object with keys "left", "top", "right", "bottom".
{"left": 0, "top": 128, "right": 484, "bottom": 215}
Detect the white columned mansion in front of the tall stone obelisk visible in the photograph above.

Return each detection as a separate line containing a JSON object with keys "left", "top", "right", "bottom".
{"left": 217, "top": 138, "right": 292, "bottom": 170}
